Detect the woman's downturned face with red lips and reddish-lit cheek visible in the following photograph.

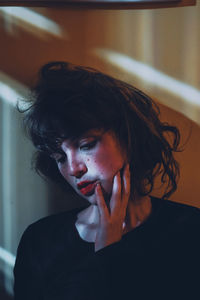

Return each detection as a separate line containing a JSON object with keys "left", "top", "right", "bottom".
{"left": 53, "top": 130, "right": 126, "bottom": 204}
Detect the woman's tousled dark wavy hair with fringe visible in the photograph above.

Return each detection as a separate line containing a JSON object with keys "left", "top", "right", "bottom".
{"left": 19, "top": 61, "right": 180, "bottom": 198}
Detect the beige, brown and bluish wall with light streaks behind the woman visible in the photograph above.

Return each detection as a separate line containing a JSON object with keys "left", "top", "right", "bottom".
{"left": 0, "top": 1, "right": 200, "bottom": 296}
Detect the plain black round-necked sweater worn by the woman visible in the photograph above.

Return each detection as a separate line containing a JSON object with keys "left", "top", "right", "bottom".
{"left": 14, "top": 197, "right": 200, "bottom": 300}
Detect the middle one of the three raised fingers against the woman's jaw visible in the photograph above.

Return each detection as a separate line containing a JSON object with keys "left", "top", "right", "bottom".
{"left": 110, "top": 171, "right": 122, "bottom": 213}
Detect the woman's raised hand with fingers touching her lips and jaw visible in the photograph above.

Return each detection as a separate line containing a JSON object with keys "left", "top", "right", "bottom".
{"left": 95, "top": 164, "right": 130, "bottom": 251}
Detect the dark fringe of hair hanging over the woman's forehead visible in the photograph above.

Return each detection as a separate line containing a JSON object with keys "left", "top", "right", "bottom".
{"left": 27, "top": 95, "right": 119, "bottom": 155}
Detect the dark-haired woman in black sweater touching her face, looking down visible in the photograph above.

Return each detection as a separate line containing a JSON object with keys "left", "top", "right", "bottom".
{"left": 14, "top": 62, "right": 200, "bottom": 300}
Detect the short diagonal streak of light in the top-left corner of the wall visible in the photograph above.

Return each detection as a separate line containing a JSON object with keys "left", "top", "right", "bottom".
{"left": 0, "top": 7, "right": 67, "bottom": 38}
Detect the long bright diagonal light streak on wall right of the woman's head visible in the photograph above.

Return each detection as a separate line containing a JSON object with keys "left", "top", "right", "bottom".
{"left": 94, "top": 48, "right": 200, "bottom": 123}
